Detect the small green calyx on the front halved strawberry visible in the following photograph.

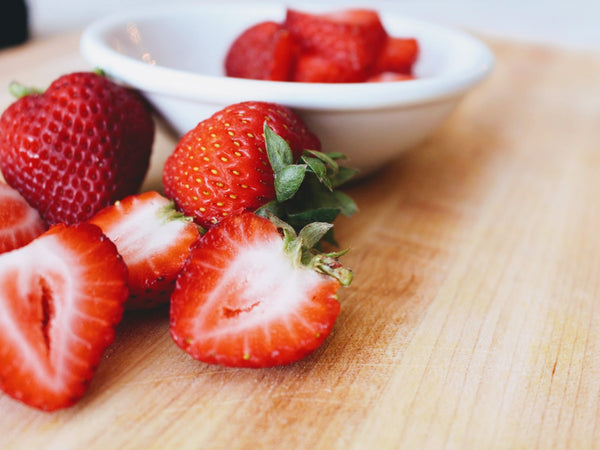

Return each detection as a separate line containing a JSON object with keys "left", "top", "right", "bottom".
{"left": 268, "top": 214, "right": 354, "bottom": 286}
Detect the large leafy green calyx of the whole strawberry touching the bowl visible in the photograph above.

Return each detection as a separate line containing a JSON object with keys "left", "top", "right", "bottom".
{"left": 256, "top": 122, "right": 358, "bottom": 245}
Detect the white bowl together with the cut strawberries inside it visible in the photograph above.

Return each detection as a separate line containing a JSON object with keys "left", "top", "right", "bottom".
{"left": 81, "top": 2, "right": 493, "bottom": 175}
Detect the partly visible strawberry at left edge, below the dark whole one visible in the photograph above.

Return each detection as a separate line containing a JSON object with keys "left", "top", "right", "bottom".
{"left": 0, "top": 183, "right": 46, "bottom": 253}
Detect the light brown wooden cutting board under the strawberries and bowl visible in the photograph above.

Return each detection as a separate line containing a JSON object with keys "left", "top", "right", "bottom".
{"left": 0, "top": 31, "right": 600, "bottom": 449}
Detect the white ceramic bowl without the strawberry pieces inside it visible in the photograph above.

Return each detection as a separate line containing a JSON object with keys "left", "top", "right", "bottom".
{"left": 81, "top": 2, "right": 493, "bottom": 175}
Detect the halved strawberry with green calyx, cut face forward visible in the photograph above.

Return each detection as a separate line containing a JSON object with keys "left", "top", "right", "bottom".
{"left": 170, "top": 212, "right": 352, "bottom": 367}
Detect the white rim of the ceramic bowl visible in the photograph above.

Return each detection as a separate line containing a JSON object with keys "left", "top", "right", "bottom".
{"left": 79, "top": 1, "right": 494, "bottom": 110}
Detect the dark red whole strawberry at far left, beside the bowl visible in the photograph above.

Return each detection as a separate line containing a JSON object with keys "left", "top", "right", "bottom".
{"left": 0, "top": 73, "right": 154, "bottom": 224}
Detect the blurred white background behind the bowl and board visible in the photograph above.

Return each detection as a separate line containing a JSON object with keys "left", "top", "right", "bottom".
{"left": 27, "top": 0, "right": 600, "bottom": 53}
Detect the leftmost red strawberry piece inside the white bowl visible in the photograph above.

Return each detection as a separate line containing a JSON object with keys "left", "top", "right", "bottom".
{"left": 225, "top": 21, "right": 299, "bottom": 81}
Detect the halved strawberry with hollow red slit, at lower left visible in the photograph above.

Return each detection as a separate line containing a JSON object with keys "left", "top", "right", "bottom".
{"left": 0, "top": 223, "right": 127, "bottom": 411}
